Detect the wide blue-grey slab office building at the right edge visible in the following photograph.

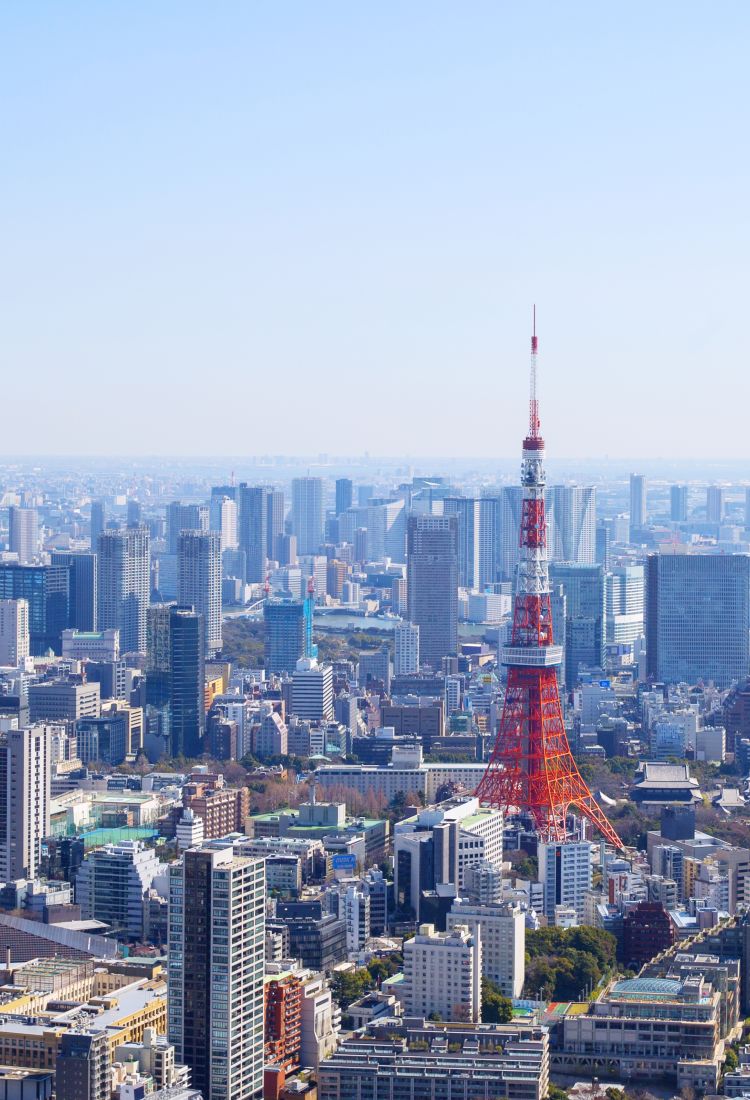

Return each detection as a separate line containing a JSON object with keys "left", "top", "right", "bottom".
{"left": 646, "top": 553, "right": 750, "bottom": 688}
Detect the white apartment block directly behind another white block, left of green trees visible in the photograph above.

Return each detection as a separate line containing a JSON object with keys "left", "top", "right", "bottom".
{"left": 446, "top": 898, "right": 526, "bottom": 997}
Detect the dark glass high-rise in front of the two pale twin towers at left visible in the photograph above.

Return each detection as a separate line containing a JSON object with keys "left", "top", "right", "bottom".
{"left": 146, "top": 605, "right": 206, "bottom": 758}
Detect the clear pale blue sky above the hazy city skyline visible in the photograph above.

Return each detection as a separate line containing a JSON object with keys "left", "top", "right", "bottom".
{"left": 0, "top": 0, "right": 750, "bottom": 459}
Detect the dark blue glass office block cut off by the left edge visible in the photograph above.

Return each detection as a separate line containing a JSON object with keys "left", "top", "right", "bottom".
{"left": 0, "top": 562, "right": 69, "bottom": 657}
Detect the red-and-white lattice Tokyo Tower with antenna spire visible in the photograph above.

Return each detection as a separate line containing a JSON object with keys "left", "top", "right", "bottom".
{"left": 475, "top": 308, "right": 622, "bottom": 849}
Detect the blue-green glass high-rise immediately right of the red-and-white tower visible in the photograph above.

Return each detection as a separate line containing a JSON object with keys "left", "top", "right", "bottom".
{"left": 550, "top": 562, "right": 605, "bottom": 689}
